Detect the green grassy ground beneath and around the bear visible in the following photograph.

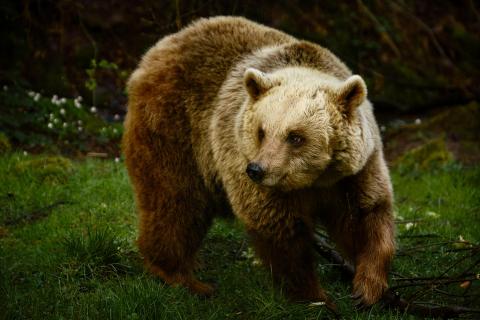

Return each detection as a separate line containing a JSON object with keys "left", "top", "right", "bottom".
{"left": 0, "top": 154, "right": 480, "bottom": 319}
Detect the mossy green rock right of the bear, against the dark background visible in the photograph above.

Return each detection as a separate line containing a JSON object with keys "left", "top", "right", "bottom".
{"left": 394, "top": 138, "right": 453, "bottom": 171}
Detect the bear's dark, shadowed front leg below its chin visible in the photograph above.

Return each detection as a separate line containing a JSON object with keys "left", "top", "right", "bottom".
{"left": 249, "top": 218, "right": 334, "bottom": 309}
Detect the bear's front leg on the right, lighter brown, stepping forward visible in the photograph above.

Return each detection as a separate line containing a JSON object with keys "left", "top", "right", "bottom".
{"left": 325, "top": 151, "right": 395, "bottom": 305}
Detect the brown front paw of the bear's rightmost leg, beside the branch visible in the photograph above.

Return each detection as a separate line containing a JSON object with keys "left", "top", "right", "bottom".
{"left": 352, "top": 274, "right": 388, "bottom": 307}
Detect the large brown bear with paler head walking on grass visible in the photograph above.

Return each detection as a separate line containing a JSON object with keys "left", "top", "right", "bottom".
{"left": 123, "top": 17, "right": 395, "bottom": 305}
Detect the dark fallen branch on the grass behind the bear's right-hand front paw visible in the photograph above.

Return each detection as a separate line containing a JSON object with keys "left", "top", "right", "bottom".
{"left": 315, "top": 233, "right": 480, "bottom": 318}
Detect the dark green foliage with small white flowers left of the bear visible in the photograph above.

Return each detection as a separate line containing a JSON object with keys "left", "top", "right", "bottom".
{"left": 0, "top": 88, "right": 122, "bottom": 152}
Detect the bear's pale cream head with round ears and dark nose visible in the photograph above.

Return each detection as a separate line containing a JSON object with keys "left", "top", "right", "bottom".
{"left": 236, "top": 67, "right": 374, "bottom": 190}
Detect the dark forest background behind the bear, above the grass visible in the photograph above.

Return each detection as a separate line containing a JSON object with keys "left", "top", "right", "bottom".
{"left": 0, "top": 0, "right": 480, "bottom": 163}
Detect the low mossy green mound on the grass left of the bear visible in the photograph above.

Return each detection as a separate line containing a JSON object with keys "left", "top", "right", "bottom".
{"left": 15, "top": 156, "right": 73, "bottom": 183}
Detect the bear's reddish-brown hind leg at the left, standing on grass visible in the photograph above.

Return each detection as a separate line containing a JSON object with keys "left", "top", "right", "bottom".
{"left": 124, "top": 125, "right": 213, "bottom": 295}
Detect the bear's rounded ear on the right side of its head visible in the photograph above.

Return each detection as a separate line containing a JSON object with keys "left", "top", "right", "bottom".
{"left": 338, "top": 75, "right": 367, "bottom": 116}
